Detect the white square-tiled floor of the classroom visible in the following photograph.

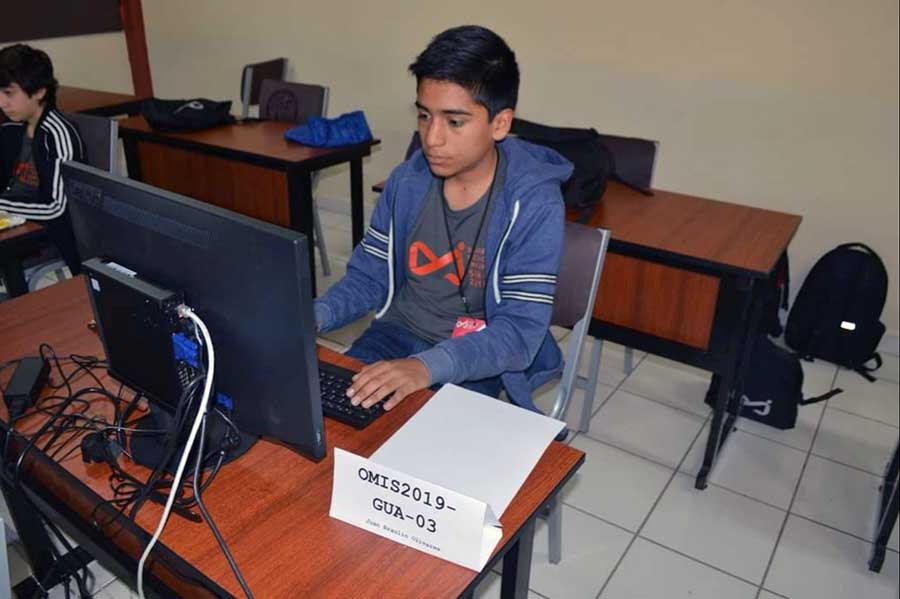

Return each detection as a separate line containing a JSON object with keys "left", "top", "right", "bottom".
{"left": 0, "top": 202, "right": 900, "bottom": 599}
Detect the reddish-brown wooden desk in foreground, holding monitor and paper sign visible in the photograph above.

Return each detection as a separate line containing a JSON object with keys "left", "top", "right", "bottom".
{"left": 0, "top": 277, "right": 584, "bottom": 599}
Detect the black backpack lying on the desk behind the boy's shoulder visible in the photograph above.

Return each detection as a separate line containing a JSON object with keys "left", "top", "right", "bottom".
{"left": 510, "top": 118, "right": 653, "bottom": 209}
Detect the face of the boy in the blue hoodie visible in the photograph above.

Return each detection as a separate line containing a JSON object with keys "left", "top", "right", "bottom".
{"left": 416, "top": 79, "right": 513, "bottom": 179}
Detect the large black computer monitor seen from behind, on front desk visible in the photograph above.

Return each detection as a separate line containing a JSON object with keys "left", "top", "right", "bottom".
{"left": 62, "top": 162, "right": 325, "bottom": 460}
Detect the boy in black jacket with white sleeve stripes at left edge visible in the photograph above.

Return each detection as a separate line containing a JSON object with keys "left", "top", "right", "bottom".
{"left": 0, "top": 44, "right": 83, "bottom": 274}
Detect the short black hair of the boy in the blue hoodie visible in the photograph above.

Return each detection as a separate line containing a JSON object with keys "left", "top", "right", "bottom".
{"left": 409, "top": 25, "right": 519, "bottom": 120}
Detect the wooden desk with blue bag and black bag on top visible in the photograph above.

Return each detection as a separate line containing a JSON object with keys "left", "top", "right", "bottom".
{"left": 119, "top": 117, "right": 380, "bottom": 295}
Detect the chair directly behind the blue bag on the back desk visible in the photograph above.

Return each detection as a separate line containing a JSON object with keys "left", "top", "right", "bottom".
{"left": 259, "top": 79, "right": 331, "bottom": 277}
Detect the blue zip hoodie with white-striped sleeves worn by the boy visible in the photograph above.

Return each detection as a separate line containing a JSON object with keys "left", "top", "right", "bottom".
{"left": 315, "top": 138, "right": 572, "bottom": 411}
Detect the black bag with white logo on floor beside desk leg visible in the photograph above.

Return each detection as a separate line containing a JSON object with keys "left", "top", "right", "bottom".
{"left": 705, "top": 334, "right": 842, "bottom": 430}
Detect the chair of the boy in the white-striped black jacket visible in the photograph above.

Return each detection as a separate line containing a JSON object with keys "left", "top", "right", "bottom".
{"left": 25, "top": 113, "right": 119, "bottom": 291}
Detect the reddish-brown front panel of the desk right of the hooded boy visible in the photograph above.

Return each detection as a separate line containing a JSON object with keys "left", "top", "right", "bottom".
{"left": 594, "top": 252, "right": 719, "bottom": 351}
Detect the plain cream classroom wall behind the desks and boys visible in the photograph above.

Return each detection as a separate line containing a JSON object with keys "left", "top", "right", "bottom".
{"left": 15, "top": 0, "right": 900, "bottom": 334}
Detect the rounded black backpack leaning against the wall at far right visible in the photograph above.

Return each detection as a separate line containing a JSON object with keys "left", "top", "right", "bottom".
{"left": 785, "top": 243, "right": 887, "bottom": 380}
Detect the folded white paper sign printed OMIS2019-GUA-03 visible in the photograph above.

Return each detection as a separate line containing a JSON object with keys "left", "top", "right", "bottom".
{"left": 329, "top": 448, "right": 502, "bottom": 571}
